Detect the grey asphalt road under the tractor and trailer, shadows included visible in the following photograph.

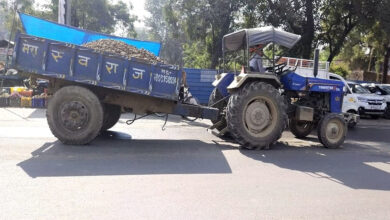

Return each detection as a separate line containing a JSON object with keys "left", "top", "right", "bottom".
{"left": 0, "top": 108, "right": 390, "bottom": 219}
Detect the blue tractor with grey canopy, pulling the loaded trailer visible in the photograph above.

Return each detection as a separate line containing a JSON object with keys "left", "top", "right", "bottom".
{"left": 209, "top": 27, "right": 347, "bottom": 149}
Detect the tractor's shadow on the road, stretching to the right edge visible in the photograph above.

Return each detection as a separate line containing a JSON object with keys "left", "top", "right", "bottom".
{"left": 240, "top": 140, "right": 390, "bottom": 191}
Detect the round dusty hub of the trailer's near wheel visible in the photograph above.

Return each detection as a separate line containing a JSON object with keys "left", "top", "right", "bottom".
{"left": 60, "top": 101, "right": 88, "bottom": 131}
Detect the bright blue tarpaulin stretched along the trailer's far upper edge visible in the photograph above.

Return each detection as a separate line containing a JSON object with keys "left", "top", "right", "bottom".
{"left": 19, "top": 13, "right": 161, "bottom": 56}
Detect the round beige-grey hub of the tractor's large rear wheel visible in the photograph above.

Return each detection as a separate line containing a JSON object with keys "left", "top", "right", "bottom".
{"left": 245, "top": 101, "right": 272, "bottom": 133}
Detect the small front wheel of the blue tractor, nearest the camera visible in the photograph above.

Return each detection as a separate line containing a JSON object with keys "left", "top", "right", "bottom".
{"left": 317, "top": 113, "right": 347, "bottom": 148}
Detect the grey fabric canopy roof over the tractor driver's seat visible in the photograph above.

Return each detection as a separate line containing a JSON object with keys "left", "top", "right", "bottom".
{"left": 222, "top": 26, "right": 301, "bottom": 51}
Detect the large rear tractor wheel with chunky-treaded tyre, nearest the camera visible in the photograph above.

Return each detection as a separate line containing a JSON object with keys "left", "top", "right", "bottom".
{"left": 227, "top": 82, "right": 287, "bottom": 149}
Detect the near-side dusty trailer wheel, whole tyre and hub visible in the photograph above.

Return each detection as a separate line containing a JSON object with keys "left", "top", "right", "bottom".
{"left": 46, "top": 86, "right": 103, "bottom": 145}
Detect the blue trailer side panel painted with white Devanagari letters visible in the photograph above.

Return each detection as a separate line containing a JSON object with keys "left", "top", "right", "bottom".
{"left": 13, "top": 34, "right": 182, "bottom": 101}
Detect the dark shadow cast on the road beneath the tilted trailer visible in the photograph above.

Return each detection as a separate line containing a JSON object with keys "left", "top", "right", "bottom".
{"left": 18, "top": 132, "right": 232, "bottom": 178}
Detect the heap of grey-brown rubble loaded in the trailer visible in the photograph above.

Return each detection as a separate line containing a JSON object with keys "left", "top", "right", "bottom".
{"left": 82, "top": 39, "right": 163, "bottom": 64}
